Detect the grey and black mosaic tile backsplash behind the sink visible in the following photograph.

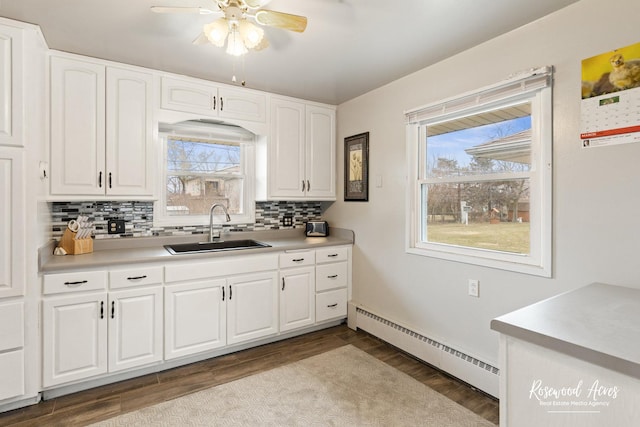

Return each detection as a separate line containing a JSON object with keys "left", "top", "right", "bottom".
{"left": 51, "top": 201, "right": 322, "bottom": 240}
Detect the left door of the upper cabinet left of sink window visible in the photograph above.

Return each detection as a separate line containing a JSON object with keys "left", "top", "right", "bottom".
{"left": 51, "top": 57, "right": 106, "bottom": 195}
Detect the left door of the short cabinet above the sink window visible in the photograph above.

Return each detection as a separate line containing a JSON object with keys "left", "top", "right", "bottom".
{"left": 160, "top": 77, "right": 218, "bottom": 117}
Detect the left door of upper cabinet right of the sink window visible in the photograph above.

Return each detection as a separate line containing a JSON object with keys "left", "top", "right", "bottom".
{"left": 268, "top": 98, "right": 307, "bottom": 199}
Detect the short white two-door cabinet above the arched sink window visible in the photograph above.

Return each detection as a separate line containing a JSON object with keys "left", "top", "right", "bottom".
{"left": 160, "top": 77, "right": 267, "bottom": 123}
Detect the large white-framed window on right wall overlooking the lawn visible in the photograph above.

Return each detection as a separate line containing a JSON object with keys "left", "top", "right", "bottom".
{"left": 406, "top": 67, "right": 552, "bottom": 277}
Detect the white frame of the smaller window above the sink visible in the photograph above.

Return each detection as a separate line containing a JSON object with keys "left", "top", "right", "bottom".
{"left": 153, "top": 123, "right": 256, "bottom": 227}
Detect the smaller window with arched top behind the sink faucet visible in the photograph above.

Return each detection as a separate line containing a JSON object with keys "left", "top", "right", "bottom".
{"left": 154, "top": 121, "right": 255, "bottom": 225}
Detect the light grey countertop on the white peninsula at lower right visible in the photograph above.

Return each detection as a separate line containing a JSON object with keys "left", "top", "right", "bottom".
{"left": 491, "top": 283, "right": 640, "bottom": 378}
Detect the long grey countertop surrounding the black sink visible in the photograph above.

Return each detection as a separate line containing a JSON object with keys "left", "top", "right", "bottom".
{"left": 39, "top": 227, "right": 354, "bottom": 273}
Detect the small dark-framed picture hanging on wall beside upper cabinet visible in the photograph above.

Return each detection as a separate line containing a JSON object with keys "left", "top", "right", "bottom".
{"left": 344, "top": 132, "right": 369, "bottom": 202}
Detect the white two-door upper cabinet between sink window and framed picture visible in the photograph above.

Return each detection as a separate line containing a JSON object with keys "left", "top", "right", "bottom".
{"left": 267, "top": 97, "right": 336, "bottom": 200}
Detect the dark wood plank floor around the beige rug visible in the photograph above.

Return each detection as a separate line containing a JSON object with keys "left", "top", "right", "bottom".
{"left": 0, "top": 325, "right": 499, "bottom": 427}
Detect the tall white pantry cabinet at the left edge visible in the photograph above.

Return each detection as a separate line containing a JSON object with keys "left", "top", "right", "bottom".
{"left": 0, "top": 18, "right": 46, "bottom": 409}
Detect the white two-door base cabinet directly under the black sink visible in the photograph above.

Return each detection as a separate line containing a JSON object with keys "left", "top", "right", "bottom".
{"left": 164, "top": 254, "right": 278, "bottom": 359}
